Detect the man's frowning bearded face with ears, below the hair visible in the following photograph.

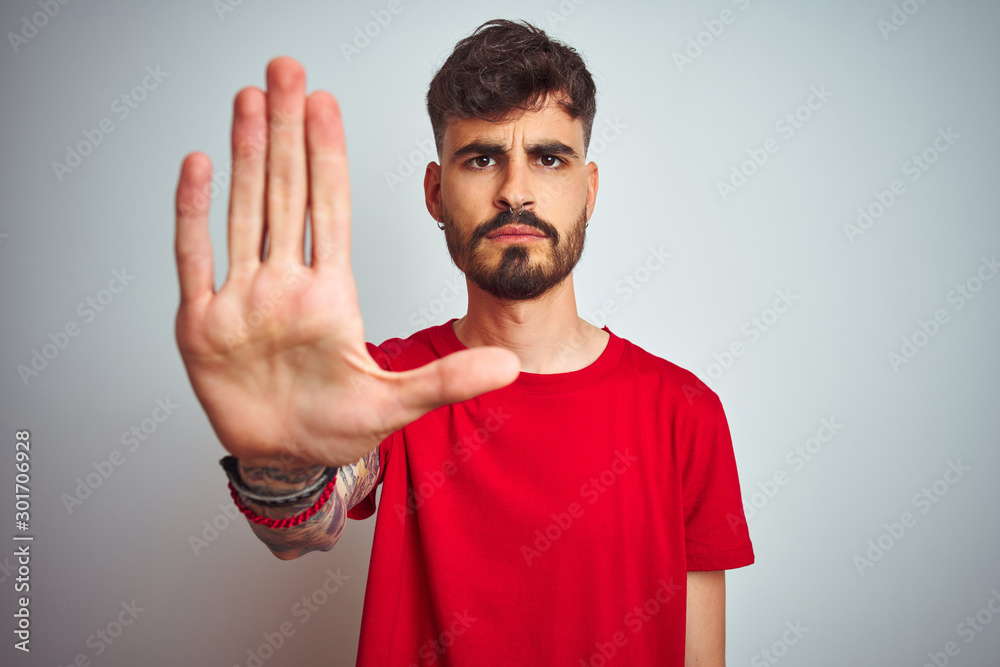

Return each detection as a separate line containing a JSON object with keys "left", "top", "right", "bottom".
{"left": 425, "top": 98, "right": 597, "bottom": 300}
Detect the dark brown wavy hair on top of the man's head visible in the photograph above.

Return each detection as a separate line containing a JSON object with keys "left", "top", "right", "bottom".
{"left": 427, "top": 19, "right": 597, "bottom": 157}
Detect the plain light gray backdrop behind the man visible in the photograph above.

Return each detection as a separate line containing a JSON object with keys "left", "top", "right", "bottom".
{"left": 0, "top": 0, "right": 1000, "bottom": 667}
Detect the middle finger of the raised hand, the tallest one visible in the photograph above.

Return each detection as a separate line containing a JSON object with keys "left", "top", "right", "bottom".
{"left": 267, "top": 57, "right": 308, "bottom": 263}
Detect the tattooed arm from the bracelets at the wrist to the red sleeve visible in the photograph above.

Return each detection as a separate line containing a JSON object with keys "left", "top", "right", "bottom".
{"left": 240, "top": 447, "right": 379, "bottom": 560}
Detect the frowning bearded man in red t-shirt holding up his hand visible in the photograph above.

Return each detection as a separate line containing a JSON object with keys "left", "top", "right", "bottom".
{"left": 176, "top": 21, "right": 754, "bottom": 667}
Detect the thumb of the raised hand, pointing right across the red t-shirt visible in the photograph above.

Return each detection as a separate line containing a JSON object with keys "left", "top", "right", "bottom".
{"left": 390, "top": 346, "right": 520, "bottom": 423}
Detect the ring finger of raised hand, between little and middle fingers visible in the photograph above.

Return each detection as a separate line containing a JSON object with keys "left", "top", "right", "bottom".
{"left": 229, "top": 87, "right": 267, "bottom": 276}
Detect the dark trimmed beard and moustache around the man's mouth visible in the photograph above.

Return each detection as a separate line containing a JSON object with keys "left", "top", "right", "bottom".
{"left": 441, "top": 206, "right": 587, "bottom": 301}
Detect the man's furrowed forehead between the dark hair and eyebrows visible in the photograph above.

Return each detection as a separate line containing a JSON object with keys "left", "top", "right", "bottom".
{"left": 443, "top": 97, "right": 583, "bottom": 155}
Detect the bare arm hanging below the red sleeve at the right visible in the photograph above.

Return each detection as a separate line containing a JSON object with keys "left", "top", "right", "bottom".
{"left": 684, "top": 570, "right": 726, "bottom": 667}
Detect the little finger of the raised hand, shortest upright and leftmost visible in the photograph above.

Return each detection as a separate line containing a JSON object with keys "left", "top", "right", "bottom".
{"left": 174, "top": 153, "right": 215, "bottom": 305}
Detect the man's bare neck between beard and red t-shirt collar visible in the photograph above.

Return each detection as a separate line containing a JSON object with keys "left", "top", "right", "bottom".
{"left": 452, "top": 274, "right": 609, "bottom": 374}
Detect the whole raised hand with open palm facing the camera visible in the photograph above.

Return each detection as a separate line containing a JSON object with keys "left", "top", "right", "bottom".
{"left": 175, "top": 57, "right": 518, "bottom": 465}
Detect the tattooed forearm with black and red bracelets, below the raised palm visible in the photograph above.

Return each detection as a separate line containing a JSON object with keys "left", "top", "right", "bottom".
{"left": 239, "top": 461, "right": 347, "bottom": 560}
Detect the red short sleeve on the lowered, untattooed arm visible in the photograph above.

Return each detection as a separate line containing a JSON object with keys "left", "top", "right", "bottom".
{"left": 680, "top": 391, "right": 754, "bottom": 571}
